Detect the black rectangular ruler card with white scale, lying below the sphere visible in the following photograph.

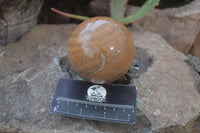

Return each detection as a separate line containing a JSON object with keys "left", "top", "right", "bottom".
{"left": 50, "top": 78, "right": 137, "bottom": 123}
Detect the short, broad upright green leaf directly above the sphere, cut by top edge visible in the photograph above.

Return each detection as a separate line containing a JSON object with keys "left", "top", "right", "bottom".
{"left": 110, "top": 0, "right": 127, "bottom": 20}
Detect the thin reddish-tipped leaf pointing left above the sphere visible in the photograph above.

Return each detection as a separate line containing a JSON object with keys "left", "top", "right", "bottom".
{"left": 51, "top": 8, "right": 89, "bottom": 21}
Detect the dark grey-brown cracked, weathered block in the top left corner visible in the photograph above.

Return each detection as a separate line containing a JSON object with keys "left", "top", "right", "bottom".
{"left": 0, "top": 0, "right": 44, "bottom": 45}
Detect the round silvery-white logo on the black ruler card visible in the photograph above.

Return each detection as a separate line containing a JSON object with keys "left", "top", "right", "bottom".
{"left": 86, "top": 85, "right": 107, "bottom": 102}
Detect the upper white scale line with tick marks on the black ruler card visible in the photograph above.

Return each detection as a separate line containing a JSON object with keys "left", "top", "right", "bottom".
{"left": 56, "top": 97, "right": 134, "bottom": 111}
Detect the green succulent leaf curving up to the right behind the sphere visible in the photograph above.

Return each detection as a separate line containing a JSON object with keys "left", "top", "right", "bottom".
{"left": 119, "top": 0, "right": 159, "bottom": 24}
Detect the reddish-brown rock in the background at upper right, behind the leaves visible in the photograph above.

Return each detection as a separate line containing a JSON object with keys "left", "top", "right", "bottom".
{"left": 128, "top": 0, "right": 200, "bottom": 53}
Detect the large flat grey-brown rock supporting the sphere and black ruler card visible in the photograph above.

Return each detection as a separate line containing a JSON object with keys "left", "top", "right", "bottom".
{"left": 0, "top": 25, "right": 200, "bottom": 133}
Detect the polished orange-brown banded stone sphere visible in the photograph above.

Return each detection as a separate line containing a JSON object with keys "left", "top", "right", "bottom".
{"left": 68, "top": 17, "right": 135, "bottom": 84}
